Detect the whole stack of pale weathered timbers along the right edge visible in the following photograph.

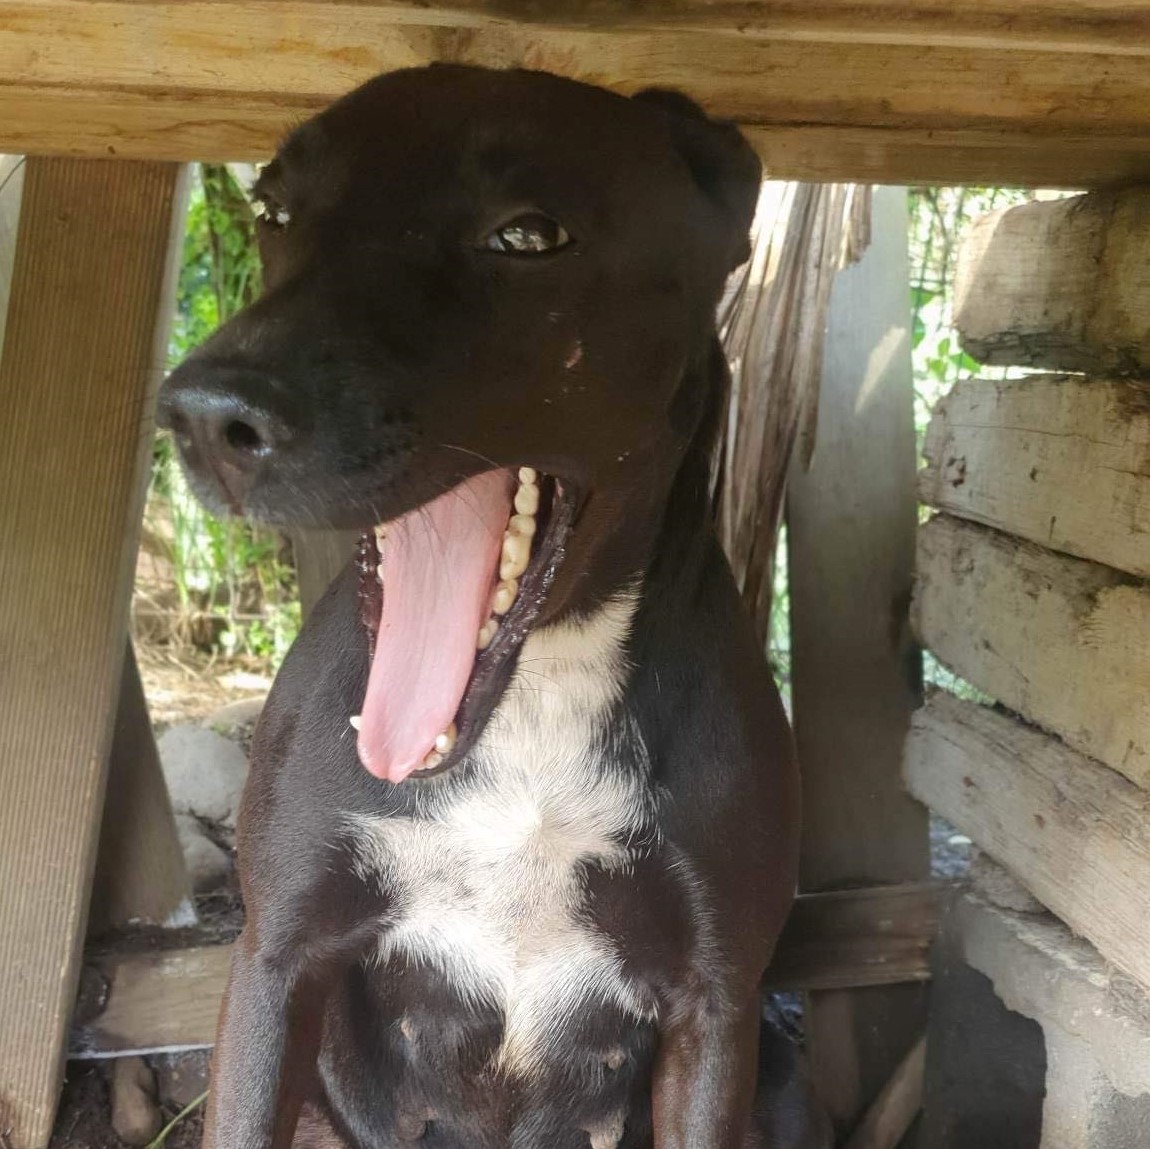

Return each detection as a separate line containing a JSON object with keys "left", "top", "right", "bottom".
{"left": 905, "top": 189, "right": 1150, "bottom": 1149}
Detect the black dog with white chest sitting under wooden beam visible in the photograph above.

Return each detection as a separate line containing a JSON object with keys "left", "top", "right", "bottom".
{"left": 161, "top": 67, "right": 798, "bottom": 1149}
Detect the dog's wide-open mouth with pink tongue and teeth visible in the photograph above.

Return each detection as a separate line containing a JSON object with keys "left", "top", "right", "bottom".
{"left": 351, "top": 467, "right": 573, "bottom": 782}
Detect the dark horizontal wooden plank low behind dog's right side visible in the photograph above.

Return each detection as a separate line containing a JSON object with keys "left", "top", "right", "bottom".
{"left": 766, "top": 882, "right": 941, "bottom": 990}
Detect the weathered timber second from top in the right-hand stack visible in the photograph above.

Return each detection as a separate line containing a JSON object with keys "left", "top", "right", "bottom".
{"left": 919, "top": 376, "right": 1150, "bottom": 579}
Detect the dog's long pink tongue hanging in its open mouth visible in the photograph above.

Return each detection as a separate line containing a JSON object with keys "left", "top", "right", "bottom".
{"left": 358, "top": 470, "right": 513, "bottom": 782}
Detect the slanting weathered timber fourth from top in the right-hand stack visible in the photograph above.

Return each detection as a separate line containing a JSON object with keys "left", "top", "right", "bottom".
{"left": 905, "top": 694, "right": 1150, "bottom": 1012}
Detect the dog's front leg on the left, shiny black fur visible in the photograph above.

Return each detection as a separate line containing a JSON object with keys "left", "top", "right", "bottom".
{"left": 204, "top": 929, "right": 330, "bottom": 1149}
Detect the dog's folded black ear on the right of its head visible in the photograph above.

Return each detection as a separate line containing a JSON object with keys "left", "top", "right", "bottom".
{"left": 633, "top": 87, "right": 762, "bottom": 271}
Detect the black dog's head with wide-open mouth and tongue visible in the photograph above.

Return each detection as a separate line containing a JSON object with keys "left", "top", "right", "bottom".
{"left": 160, "top": 66, "right": 760, "bottom": 778}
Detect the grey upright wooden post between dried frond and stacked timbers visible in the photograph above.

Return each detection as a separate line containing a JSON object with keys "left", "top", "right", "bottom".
{"left": 788, "top": 187, "right": 929, "bottom": 1133}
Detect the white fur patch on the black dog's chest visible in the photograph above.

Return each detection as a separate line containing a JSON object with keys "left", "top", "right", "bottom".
{"left": 345, "top": 596, "right": 651, "bottom": 1072}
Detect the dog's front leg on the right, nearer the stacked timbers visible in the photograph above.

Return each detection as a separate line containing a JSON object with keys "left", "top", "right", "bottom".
{"left": 652, "top": 990, "right": 759, "bottom": 1149}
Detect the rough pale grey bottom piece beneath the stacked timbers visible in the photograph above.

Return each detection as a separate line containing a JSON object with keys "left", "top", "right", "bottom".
{"left": 946, "top": 896, "right": 1150, "bottom": 1131}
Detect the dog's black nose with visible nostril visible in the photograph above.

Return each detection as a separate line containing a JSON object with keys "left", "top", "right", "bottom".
{"left": 156, "top": 362, "right": 293, "bottom": 514}
